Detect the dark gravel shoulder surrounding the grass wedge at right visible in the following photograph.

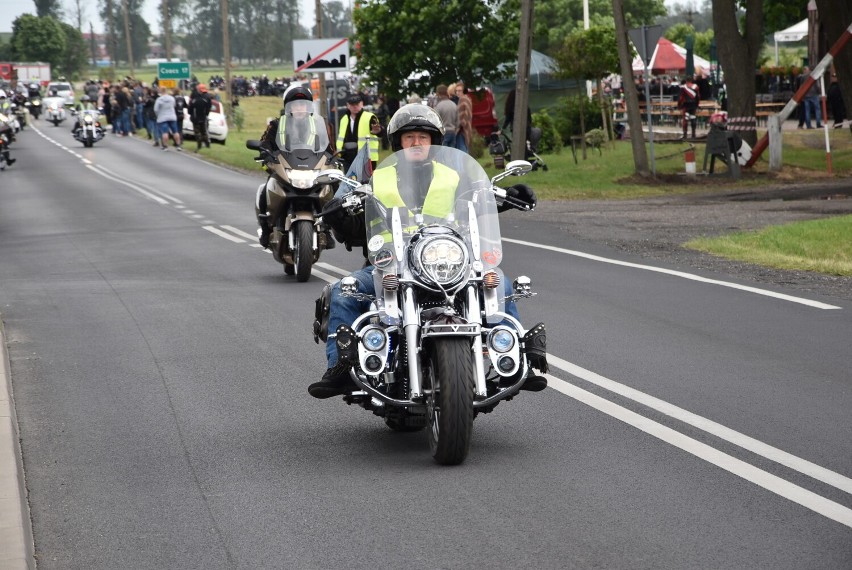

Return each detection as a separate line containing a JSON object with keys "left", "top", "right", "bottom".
{"left": 523, "top": 179, "right": 852, "bottom": 300}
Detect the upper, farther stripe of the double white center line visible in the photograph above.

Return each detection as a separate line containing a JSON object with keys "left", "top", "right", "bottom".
{"left": 547, "top": 354, "right": 852, "bottom": 493}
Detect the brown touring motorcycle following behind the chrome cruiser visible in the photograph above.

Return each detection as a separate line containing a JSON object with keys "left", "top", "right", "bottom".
{"left": 246, "top": 103, "right": 336, "bottom": 282}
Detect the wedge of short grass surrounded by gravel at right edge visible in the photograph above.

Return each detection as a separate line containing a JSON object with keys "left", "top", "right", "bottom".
{"left": 684, "top": 215, "right": 852, "bottom": 275}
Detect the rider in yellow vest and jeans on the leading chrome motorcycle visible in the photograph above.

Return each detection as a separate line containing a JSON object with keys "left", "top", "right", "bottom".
{"left": 308, "top": 104, "right": 547, "bottom": 399}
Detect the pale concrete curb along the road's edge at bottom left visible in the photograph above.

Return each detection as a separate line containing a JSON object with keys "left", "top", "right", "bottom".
{"left": 0, "top": 319, "right": 36, "bottom": 570}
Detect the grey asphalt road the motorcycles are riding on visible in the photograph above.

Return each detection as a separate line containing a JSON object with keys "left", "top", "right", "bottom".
{"left": 0, "top": 125, "right": 852, "bottom": 570}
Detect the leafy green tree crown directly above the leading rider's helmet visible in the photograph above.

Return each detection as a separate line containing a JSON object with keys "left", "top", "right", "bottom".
{"left": 353, "top": 0, "right": 519, "bottom": 96}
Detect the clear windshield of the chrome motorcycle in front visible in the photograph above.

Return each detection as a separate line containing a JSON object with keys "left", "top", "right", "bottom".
{"left": 364, "top": 146, "right": 503, "bottom": 271}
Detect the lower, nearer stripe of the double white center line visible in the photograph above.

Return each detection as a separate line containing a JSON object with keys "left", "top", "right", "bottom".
{"left": 546, "top": 374, "right": 852, "bottom": 528}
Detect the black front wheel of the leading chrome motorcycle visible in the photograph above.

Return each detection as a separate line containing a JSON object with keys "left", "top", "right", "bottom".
{"left": 427, "top": 337, "right": 474, "bottom": 465}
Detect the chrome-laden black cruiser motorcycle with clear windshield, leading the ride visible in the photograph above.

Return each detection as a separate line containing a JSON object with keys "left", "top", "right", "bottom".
{"left": 314, "top": 147, "right": 547, "bottom": 465}
